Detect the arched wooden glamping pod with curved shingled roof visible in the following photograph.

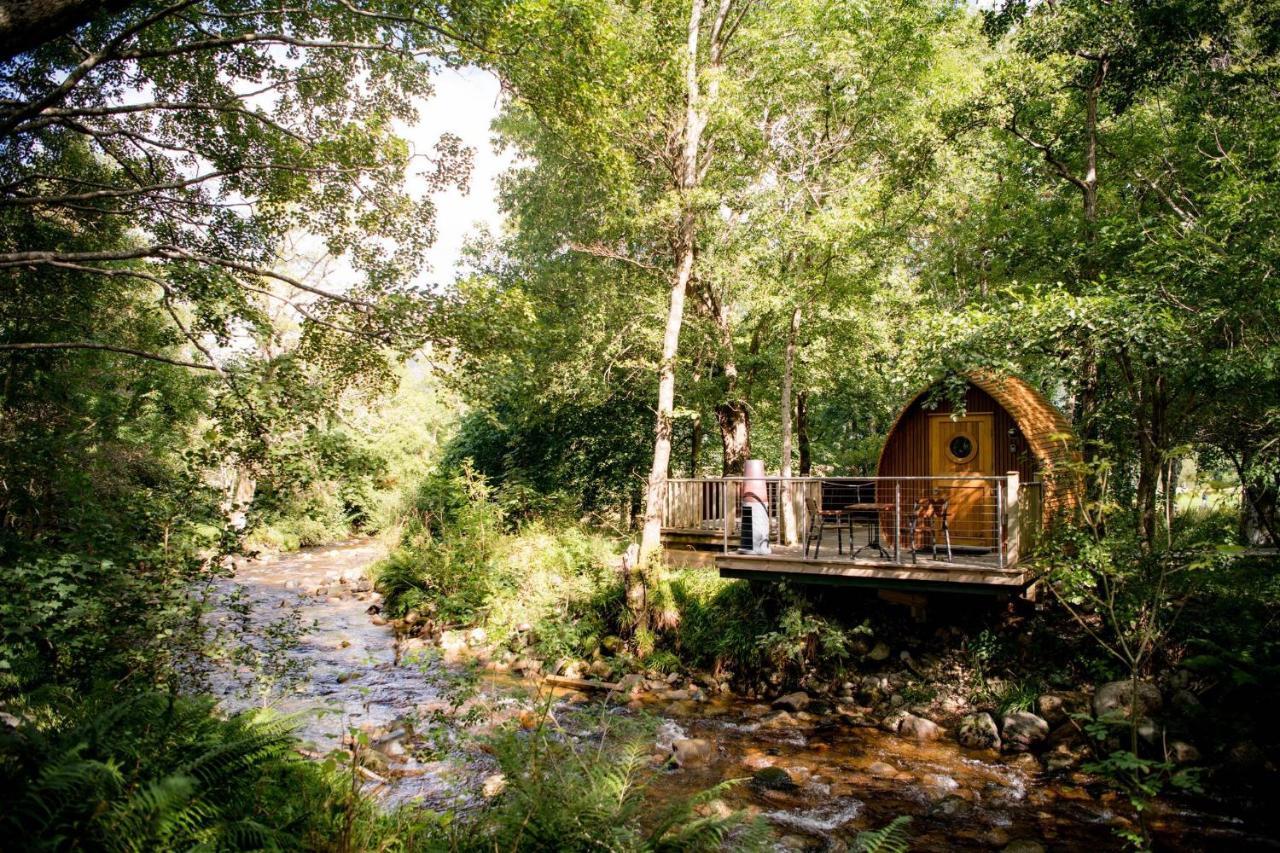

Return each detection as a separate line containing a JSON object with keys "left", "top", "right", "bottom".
{"left": 877, "top": 373, "right": 1079, "bottom": 549}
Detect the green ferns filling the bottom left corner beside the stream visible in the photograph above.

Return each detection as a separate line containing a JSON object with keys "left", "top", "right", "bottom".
{"left": 0, "top": 693, "right": 440, "bottom": 850}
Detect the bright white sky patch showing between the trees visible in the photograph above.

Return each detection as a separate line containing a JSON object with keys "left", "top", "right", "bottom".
{"left": 404, "top": 68, "right": 512, "bottom": 284}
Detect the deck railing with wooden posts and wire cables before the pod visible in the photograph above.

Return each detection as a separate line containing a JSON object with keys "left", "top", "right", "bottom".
{"left": 663, "top": 473, "right": 1041, "bottom": 569}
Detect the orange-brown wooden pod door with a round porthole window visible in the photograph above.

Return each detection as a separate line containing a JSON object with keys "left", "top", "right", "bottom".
{"left": 929, "top": 414, "right": 997, "bottom": 548}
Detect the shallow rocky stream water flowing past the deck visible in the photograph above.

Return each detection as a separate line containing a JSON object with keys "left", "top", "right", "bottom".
{"left": 211, "top": 540, "right": 1280, "bottom": 853}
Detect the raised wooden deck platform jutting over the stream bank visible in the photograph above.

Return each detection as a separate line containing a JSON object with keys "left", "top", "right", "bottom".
{"left": 663, "top": 530, "right": 1036, "bottom": 596}
